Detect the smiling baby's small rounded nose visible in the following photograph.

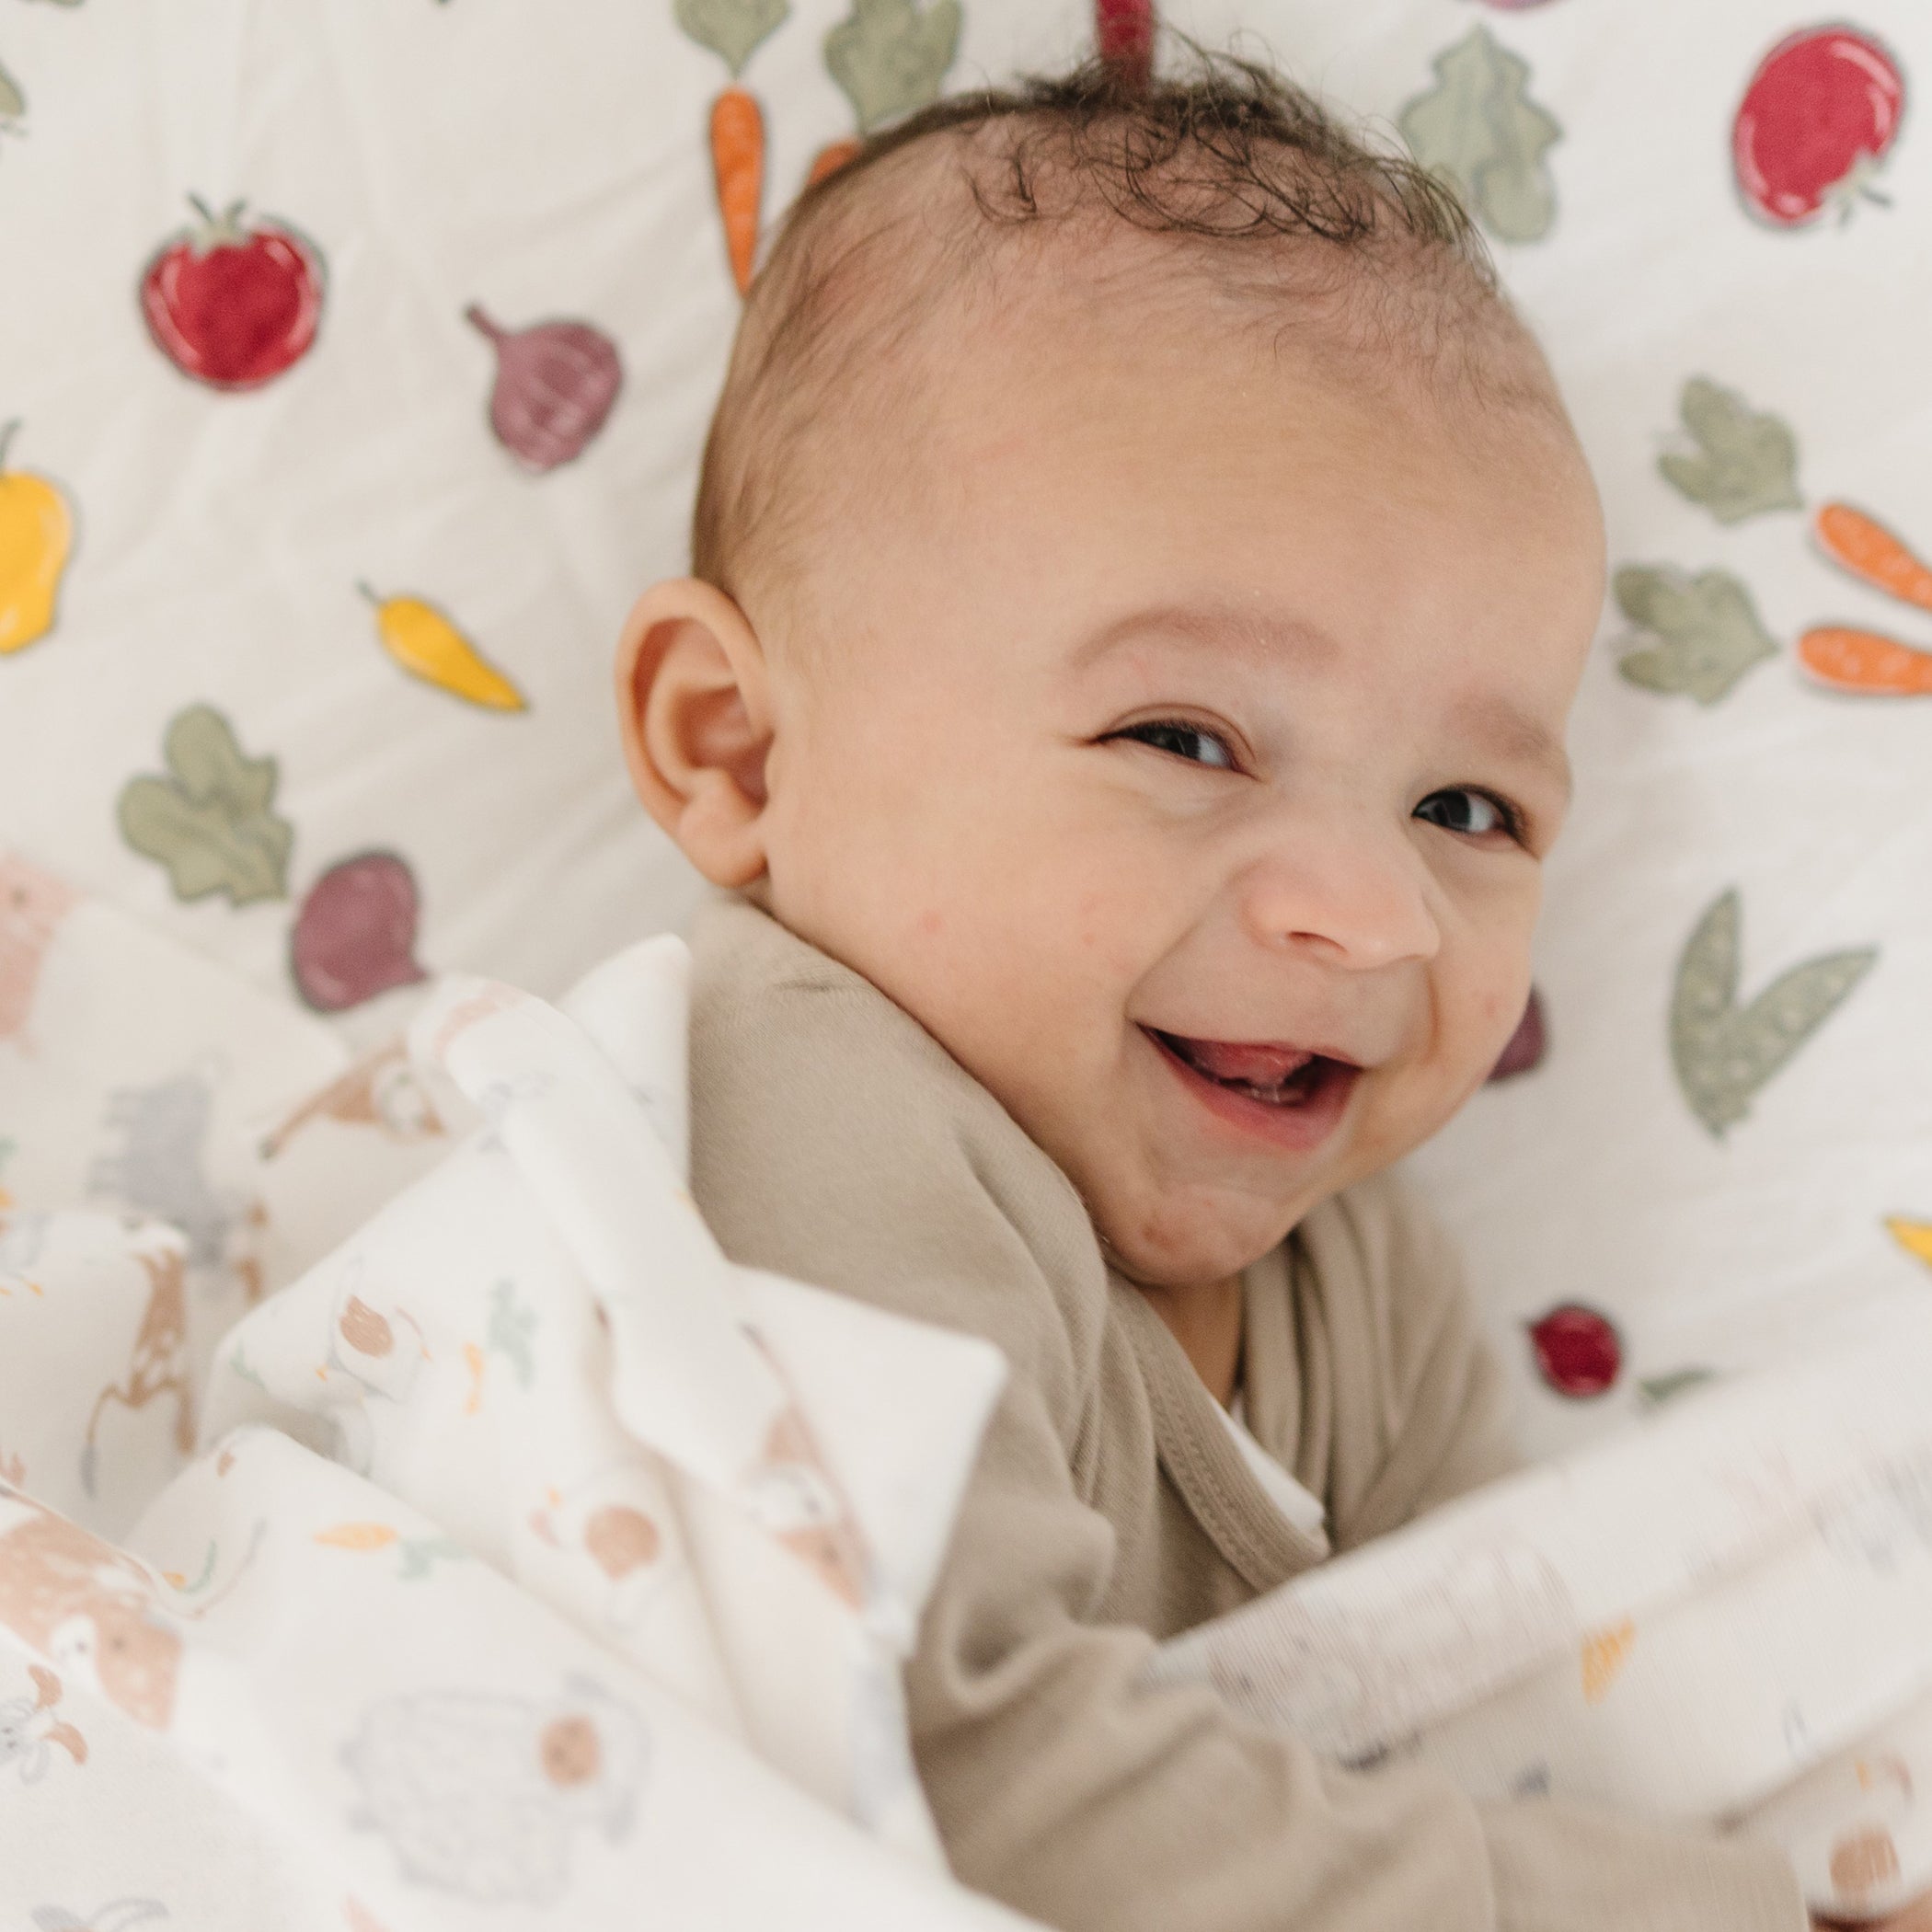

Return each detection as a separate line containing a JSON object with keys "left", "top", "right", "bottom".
{"left": 1238, "top": 817, "right": 1442, "bottom": 972}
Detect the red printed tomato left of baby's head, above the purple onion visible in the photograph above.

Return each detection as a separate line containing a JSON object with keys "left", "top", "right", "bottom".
{"left": 141, "top": 197, "right": 327, "bottom": 388}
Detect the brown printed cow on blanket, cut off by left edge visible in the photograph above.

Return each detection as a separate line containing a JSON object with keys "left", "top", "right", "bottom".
{"left": 0, "top": 1491, "right": 181, "bottom": 1731}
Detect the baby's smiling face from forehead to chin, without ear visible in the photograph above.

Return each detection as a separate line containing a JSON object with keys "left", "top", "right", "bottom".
{"left": 738, "top": 285, "right": 1602, "bottom": 1287}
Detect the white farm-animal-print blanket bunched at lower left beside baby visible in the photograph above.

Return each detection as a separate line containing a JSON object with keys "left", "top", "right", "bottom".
{"left": 0, "top": 884, "right": 1018, "bottom": 1932}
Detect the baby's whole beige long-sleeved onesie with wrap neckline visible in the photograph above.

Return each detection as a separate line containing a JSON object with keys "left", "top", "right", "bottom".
{"left": 692, "top": 894, "right": 1809, "bottom": 1932}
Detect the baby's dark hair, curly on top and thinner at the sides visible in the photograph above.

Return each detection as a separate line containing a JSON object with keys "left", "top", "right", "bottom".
{"left": 692, "top": 40, "right": 1563, "bottom": 601}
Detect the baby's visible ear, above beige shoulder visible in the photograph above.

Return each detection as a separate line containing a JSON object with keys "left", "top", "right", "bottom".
{"left": 616, "top": 578, "right": 771, "bottom": 887}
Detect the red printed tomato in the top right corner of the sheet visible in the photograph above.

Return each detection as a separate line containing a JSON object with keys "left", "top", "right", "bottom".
{"left": 1731, "top": 25, "right": 1905, "bottom": 228}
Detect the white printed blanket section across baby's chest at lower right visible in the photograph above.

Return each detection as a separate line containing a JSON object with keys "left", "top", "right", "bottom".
{"left": 1154, "top": 1294, "right": 1932, "bottom": 1916}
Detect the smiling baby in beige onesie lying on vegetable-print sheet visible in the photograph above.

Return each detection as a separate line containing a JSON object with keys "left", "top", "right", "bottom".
{"left": 618, "top": 41, "right": 1916, "bottom": 1932}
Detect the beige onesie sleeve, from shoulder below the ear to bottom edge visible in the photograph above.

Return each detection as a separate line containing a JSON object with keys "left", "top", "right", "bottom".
{"left": 692, "top": 907, "right": 1807, "bottom": 1932}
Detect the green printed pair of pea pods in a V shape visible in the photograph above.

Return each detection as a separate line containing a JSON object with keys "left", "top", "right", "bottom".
{"left": 1672, "top": 887, "right": 1878, "bottom": 1140}
